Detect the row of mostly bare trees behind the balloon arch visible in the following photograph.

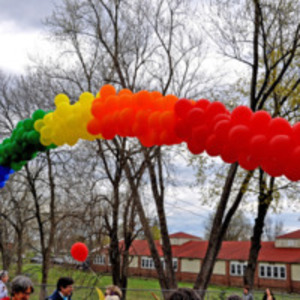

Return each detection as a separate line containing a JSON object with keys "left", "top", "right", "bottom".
{"left": 0, "top": 0, "right": 300, "bottom": 299}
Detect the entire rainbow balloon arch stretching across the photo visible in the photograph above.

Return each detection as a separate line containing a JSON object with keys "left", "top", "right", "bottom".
{"left": 0, "top": 85, "right": 300, "bottom": 187}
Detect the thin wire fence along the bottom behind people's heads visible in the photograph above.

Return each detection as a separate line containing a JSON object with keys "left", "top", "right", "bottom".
{"left": 30, "top": 285, "right": 300, "bottom": 300}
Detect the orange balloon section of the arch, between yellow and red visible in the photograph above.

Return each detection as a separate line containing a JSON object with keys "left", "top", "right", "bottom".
{"left": 87, "top": 85, "right": 181, "bottom": 147}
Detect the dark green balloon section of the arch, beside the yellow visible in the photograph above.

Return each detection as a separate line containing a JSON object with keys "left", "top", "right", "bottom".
{"left": 0, "top": 109, "right": 55, "bottom": 171}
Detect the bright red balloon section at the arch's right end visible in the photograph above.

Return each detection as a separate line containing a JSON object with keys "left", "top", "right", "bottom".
{"left": 175, "top": 99, "right": 300, "bottom": 181}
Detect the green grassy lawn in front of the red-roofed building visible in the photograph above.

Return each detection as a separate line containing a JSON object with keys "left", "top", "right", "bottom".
{"left": 2, "top": 264, "right": 299, "bottom": 300}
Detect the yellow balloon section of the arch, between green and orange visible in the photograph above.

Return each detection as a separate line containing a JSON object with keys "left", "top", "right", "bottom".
{"left": 34, "top": 92, "right": 102, "bottom": 146}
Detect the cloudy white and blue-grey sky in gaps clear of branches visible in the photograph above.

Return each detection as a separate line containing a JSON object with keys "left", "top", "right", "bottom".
{"left": 0, "top": 0, "right": 300, "bottom": 236}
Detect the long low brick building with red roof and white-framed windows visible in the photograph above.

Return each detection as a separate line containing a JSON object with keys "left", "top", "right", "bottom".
{"left": 93, "top": 230, "right": 300, "bottom": 292}
